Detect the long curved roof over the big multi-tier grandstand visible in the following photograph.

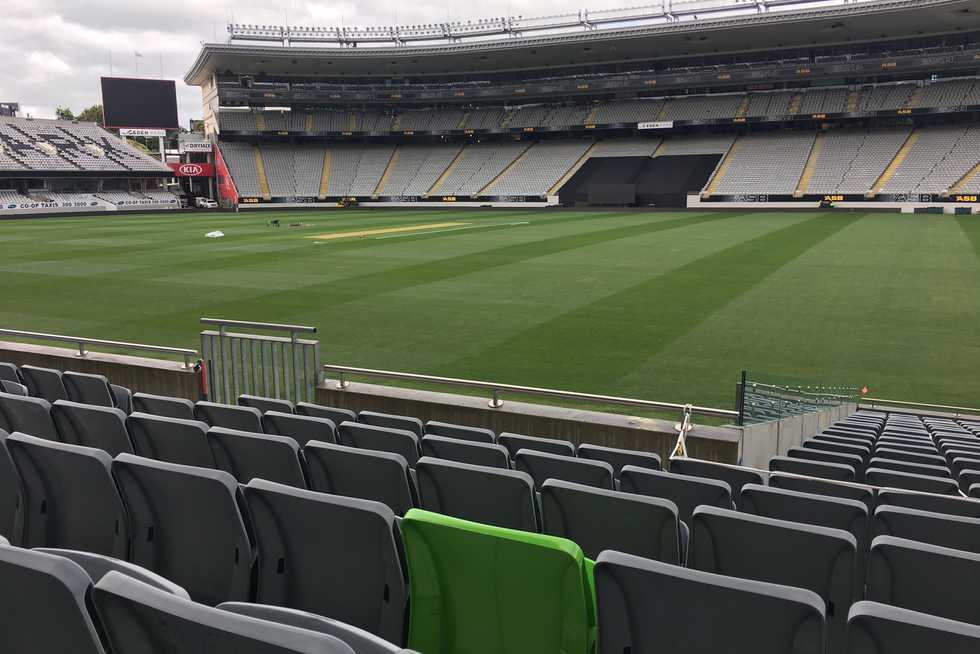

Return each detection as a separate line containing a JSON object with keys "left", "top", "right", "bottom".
{"left": 184, "top": 0, "right": 980, "bottom": 86}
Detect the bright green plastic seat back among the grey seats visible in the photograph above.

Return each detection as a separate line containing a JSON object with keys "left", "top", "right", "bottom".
{"left": 402, "top": 509, "right": 595, "bottom": 654}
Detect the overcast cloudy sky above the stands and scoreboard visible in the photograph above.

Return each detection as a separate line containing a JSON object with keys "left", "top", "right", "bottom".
{"left": 0, "top": 0, "right": 639, "bottom": 127}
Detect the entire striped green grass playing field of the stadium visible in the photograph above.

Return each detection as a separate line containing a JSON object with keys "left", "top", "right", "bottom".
{"left": 0, "top": 209, "right": 980, "bottom": 416}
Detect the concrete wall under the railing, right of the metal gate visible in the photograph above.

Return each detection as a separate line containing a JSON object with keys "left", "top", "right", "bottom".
{"left": 317, "top": 381, "right": 741, "bottom": 463}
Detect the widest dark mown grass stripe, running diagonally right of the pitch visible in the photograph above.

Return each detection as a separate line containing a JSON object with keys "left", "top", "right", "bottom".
{"left": 438, "top": 215, "right": 854, "bottom": 392}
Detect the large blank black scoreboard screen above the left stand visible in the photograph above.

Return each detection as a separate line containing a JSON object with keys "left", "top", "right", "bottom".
{"left": 102, "top": 77, "right": 178, "bottom": 129}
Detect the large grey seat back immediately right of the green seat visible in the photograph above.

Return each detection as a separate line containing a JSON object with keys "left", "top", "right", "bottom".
{"left": 595, "top": 552, "right": 824, "bottom": 654}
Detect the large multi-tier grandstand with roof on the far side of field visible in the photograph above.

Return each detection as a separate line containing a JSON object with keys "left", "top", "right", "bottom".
{"left": 185, "top": 0, "right": 980, "bottom": 210}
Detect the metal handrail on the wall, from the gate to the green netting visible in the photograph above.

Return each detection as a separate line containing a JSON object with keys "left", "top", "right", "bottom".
{"left": 323, "top": 364, "right": 738, "bottom": 422}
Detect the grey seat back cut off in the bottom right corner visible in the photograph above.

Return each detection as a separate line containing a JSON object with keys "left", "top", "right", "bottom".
{"left": 847, "top": 602, "right": 980, "bottom": 654}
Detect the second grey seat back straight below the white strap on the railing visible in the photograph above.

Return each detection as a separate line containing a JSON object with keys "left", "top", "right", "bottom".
{"left": 619, "top": 466, "right": 734, "bottom": 525}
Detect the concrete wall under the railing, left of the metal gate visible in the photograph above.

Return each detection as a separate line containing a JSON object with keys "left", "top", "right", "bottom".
{"left": 0, "top": 341, "right": 204, "bottom": 401}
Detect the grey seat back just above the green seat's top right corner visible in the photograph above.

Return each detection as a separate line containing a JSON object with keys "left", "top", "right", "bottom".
{"left": 541, "top": 479, "right": 684, "bottom": 565}
